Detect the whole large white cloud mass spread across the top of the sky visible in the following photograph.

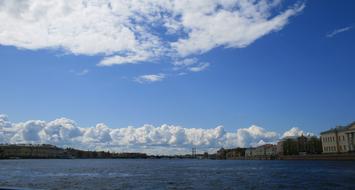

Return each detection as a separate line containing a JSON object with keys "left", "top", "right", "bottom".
{"left": 0, "top": 0, "right": 305, "bottom": 79}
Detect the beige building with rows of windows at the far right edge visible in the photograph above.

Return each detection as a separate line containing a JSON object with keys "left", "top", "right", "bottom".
{"left": 321, "top": 122, "right": 355, "bottom": 153}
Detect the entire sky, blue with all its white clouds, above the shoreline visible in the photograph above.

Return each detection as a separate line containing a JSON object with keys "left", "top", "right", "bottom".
{"left": 0, "top": 0, "right": 355, "bottom": 154}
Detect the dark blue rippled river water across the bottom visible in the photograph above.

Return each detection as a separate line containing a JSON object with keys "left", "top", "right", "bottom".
{"left": 0, "top": 160, "right": 355, "bottom": 189}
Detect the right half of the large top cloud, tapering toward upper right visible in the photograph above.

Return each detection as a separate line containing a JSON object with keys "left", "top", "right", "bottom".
{"left": 172, "top": 0, "right": 304, "bottom": 56}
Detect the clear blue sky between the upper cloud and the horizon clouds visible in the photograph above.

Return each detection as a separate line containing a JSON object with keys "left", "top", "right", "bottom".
{"left": 0, "top": 0, "right": 355, "bottom": 151}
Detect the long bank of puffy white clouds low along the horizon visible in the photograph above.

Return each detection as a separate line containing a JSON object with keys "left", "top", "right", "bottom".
{"left": 0, "top": 115, "right": 309, "bottom": 154}
